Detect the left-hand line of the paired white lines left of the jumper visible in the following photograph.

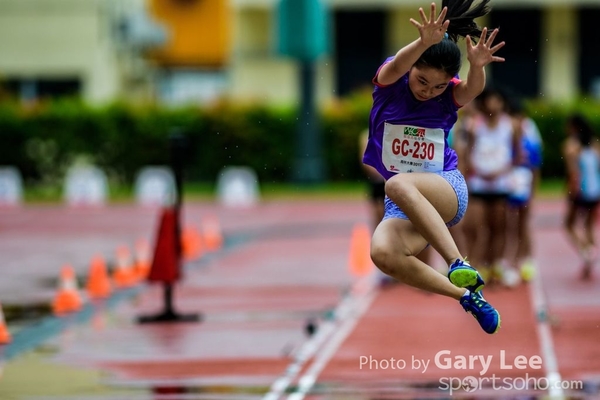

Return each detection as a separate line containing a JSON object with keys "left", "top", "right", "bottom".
{"left": 263, "top": 275, "right": 374, "bottom": 400}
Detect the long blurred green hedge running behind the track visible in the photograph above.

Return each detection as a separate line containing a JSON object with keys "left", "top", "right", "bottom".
{"left": 0, "top": 92, "right": 600, "bottom": 192}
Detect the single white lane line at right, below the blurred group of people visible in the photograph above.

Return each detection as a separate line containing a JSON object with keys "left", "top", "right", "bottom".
{"left": 529, "top": 266, "right": 565, "bottom": 399}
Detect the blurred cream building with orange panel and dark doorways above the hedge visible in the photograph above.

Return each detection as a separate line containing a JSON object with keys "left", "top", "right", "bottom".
{"left": 0, "top": 0, "right": 600, "bottom": 104}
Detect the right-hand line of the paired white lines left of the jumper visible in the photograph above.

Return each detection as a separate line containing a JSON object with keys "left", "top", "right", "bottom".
{"left": 287, "top": 278, "right": 376, "bottom": 400}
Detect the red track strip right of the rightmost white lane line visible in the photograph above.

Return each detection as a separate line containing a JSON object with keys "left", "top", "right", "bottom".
{"left": 535, "top": 200, "right": 600, "bottom": 390}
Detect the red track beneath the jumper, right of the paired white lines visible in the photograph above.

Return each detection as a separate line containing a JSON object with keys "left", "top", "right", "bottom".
{"left": 267, "top": 201, "right": 600, "bottom": 400}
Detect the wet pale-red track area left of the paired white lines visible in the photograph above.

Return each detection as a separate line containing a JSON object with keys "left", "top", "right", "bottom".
{"left": 0, "top": 201, "right": 368, "bottom": 399}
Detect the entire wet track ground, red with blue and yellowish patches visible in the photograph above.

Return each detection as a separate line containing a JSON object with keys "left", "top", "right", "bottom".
{"left": 0, "top": 201, "right": 600, "bottom": 400}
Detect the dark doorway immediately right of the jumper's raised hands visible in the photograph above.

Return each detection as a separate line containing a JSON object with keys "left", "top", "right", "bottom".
{"left": 489, "top": 8, "right": 541, "bottom": 97}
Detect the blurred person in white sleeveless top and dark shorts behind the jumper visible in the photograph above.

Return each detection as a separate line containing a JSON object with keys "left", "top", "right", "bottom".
{"left": 463, "top": 88, "right": 520, "bottom": 286}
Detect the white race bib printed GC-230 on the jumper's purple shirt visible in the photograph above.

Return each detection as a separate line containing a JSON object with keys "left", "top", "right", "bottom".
{"left": 381, "top": 122, "right": 444, "bottom": 173}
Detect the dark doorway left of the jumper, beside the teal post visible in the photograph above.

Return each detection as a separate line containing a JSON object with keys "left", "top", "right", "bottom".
{"left": 335, "top": 11, "right": 386, "bottom": 97}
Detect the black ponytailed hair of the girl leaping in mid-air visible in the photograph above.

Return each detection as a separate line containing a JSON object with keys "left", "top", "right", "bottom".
{"left": 415, "top": 0, "right": 490, "bottom": 76}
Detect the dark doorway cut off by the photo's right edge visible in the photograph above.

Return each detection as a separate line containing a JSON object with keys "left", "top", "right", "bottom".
{"left": 579, "top": 8, "right": 600, "bottom": 96}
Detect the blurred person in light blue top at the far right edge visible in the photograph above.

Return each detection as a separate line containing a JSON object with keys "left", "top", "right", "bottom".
{"left": 562, "top": 114, "right": 600, "bottom": 279}
